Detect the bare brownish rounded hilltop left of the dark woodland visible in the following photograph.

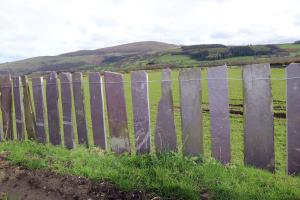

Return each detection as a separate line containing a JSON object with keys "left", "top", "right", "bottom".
{"left": 0, "top": 41, "right": 179, "bottom": 74}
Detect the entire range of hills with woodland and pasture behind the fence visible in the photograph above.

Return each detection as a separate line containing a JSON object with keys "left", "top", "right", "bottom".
{"left": 0, "top": 41, "right": 300, "bottom": 74}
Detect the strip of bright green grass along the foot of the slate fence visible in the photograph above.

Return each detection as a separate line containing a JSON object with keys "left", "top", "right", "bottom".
{"left": 0, "top": 141, "right": 300, "bottom": 200}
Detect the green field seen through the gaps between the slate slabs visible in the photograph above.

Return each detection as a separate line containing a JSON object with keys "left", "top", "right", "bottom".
{"left": 85, "top": 67, "right": 286, "bottom": 173}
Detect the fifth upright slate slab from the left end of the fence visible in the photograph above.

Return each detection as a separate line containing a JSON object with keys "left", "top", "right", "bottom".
{"left": 46, "top": 72, "right": 61, "bottom": 145}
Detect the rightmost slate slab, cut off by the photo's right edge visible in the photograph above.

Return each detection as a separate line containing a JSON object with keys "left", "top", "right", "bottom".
{"left": 286, "top": 64, "right": 300, "bottom": 174}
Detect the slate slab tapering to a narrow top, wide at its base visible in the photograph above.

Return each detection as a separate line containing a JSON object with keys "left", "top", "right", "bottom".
{"left": 154, "top": 69, "right": 177, "bottom": 153}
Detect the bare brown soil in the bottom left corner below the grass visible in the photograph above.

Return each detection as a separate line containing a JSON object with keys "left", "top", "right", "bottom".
{"left": 0, "top": 152, "right": 161, "bottom": 200}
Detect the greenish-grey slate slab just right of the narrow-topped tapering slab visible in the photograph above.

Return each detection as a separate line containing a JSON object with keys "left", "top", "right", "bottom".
{"left": 179, "top": 69, "right": 203, "bottom": 155}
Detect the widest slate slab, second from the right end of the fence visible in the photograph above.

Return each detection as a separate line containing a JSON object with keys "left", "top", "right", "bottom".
{"left": 243, "top": 64, "right": 274, "bottom": 171}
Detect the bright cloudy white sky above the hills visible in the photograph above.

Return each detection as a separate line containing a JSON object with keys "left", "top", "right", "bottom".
{"left": 0, "top": 0, "right": 300, "bottom": 63}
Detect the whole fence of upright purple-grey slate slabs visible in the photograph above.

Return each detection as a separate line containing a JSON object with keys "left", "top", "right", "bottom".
{"left": 0, "top": 64, "right": 300, "bottom": 174}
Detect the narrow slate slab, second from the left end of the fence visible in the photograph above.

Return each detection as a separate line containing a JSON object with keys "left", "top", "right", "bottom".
{"left": 13, "top": 76, "right": 25, "bottom": 140}
